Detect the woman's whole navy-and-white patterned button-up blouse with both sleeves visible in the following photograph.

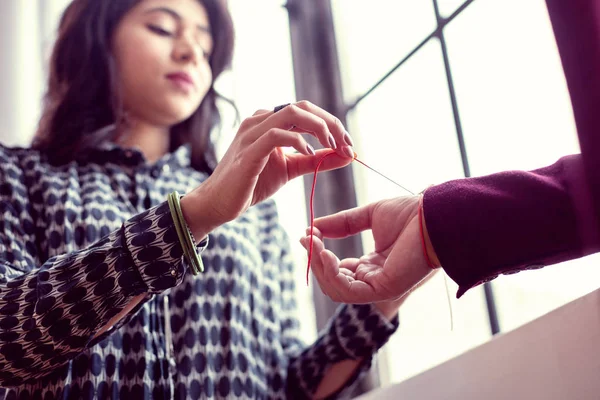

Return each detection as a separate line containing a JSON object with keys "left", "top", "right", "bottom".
{"left": 0, "top": 145, "right": 397, "bottom": 400}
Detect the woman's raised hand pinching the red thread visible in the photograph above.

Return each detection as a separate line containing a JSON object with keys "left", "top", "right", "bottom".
{"left": 181, "top": 101, "right": 354, "bottom": 240}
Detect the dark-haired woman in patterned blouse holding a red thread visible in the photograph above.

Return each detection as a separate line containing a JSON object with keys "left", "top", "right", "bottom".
{"left": 0, "top": 0, "right": 408, "bottom": 399}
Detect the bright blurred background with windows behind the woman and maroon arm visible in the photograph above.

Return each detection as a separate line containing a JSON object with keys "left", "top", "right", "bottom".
{"left": 0, "top": 0, "right": 600, "bottom": 396}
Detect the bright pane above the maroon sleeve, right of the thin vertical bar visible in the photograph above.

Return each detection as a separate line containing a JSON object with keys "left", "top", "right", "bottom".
{"left": 445, "top": 0, "right": 579, "bottom": 175}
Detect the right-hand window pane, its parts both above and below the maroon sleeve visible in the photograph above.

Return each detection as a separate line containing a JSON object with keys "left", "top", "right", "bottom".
{"left": 446, "top": 0, "right": 600, "bottom": 330}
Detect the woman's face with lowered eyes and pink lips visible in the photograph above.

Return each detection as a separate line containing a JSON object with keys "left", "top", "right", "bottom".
{"left": 112, "top": 0, "right": 213, "bottom": 127}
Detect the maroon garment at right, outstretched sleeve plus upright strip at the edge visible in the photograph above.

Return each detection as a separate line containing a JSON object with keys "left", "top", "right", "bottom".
{"left": 423, "top": 0, "right": 600, "bottom": 296}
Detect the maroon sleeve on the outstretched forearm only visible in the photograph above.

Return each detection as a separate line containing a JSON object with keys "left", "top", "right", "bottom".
{"left": 423, "top": 155, "right": 600, "bottom": 297}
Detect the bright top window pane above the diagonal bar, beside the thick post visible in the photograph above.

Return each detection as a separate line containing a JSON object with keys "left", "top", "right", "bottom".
{"left": 331, "top": 0, "right": 436, "bottom": 101}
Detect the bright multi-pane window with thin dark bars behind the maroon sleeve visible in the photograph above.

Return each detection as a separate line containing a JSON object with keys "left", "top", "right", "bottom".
{"left": 332, "top": 0, "right": 600, "bottom": 384}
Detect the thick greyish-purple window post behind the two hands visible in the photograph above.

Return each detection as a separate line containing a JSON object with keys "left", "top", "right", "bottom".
{"left": 285, "top": 0, "right": 379, "bottom": 397}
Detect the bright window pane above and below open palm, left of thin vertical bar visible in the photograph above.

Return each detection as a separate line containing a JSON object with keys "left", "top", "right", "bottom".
{"left": 349, "top": 40, "right": 490, "bottom": 382}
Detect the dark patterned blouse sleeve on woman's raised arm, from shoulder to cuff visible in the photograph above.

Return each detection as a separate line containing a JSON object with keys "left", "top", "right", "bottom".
{"left": 0, "top": 147, "right": 185, "bottom": 387}
